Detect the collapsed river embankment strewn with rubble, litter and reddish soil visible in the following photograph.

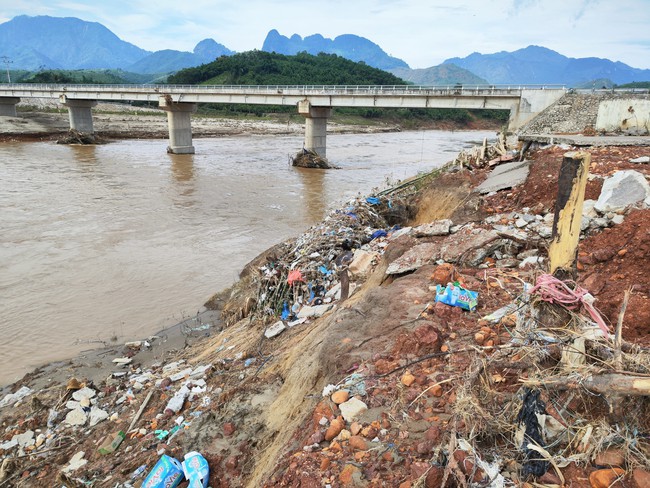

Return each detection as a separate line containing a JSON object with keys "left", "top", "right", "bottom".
{"left": 0, "top": 139, "right": 650, "bottom": 487}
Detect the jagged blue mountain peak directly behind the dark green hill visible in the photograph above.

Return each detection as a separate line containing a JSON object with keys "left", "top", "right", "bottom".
{"left": 262, "top": 29, "right": 408, "bottom": 70}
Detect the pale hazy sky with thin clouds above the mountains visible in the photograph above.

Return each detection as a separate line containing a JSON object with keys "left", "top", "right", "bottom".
{"left": 0, "top": 0, "right": 650, "bottom": 68}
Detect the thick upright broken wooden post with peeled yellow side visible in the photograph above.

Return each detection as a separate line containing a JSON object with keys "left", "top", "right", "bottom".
{"left": 548, "top": 152, "right": 591, "bottom": 279}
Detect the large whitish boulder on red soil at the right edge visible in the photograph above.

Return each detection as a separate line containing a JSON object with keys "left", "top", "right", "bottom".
{"left": 595, "top": 170, "right": 650, "bottom": 213}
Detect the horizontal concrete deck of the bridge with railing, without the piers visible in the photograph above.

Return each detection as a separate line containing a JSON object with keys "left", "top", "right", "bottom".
{"left": 0, "top": 84, "right": 564, "bottom": 109}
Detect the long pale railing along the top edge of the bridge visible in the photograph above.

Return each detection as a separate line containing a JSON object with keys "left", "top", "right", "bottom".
{"left": 0, "top": 83, "right": 565, "bottom": 96}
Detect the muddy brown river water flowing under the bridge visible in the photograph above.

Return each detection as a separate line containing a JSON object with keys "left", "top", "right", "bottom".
{"left": 0, "top": 131, "right": 494, "bottom": 385}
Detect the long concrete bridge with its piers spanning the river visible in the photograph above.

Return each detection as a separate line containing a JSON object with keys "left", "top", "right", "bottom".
{"left": 0, "top": 84, "right": 566, "bottom": 157}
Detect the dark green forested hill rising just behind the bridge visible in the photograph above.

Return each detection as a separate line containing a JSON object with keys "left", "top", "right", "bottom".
{"left": 169, "top": 51, "right": 407, "bottom": 85}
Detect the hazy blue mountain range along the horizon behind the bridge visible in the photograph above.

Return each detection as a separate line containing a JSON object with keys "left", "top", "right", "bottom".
{"left": 0, "top": 15, "right": 650, "bottom": 87}
